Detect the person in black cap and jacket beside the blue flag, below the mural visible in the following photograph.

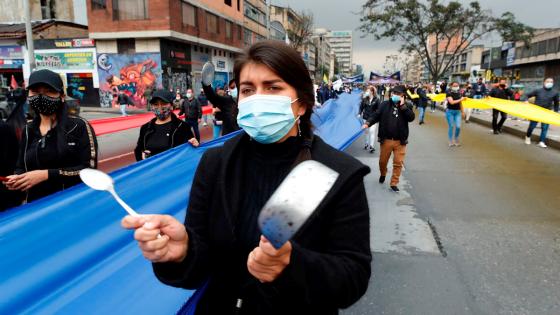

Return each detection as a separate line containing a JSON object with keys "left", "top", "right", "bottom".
{"left": 134, "top": 90, "right": 199, "bottom": 161}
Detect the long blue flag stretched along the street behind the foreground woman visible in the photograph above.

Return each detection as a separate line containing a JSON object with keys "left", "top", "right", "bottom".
{"left": 0, "top": 93, "right": 361, "bottom": 314}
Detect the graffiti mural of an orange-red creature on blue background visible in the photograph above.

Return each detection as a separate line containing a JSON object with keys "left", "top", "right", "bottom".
{"left": 97, "top": 53, "right": 162, "bottom": 108}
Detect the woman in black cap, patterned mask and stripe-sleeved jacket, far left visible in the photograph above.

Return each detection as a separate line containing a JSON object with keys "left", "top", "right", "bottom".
{"left": 5, "top": 70, "right": 97, "bottom": 202}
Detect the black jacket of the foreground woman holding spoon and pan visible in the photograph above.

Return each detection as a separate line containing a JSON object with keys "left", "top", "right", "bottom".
{"left": 153, "top": 134, "right": 371, "bottom": 315}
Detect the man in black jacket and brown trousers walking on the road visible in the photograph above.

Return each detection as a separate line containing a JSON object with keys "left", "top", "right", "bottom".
{"left": 362, "top": 86, "right": 414, "bottom": 192}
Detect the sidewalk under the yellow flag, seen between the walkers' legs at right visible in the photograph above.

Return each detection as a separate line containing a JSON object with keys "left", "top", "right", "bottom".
{"left": 438, "top": 105, "right": 560, "bottom": 150}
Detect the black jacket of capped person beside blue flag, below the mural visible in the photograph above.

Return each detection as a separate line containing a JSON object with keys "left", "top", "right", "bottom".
{"left": 134, "top": 113, "right": 194, "bottom": 161}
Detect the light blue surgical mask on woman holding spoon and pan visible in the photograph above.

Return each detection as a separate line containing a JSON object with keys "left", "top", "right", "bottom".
{"left": 237, "top": 94, "right": 299, "bottom": 144}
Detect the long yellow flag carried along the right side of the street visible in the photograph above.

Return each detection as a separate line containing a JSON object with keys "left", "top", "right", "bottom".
{"left": 428, "top": 94, "right": 560, "bottom": 126}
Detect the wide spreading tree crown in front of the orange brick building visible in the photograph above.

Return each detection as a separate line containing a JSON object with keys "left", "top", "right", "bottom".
{"left": 360, "top": 0, "right": 534, "bottom": 83}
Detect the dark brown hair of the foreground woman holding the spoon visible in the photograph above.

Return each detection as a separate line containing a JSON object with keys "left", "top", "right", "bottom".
{"left": 233, "top": 41, "right": 315, "bottom": 164}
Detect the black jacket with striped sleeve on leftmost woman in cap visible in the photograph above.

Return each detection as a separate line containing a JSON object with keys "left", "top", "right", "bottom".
{"left": 16, "top": 116, "right": 97, "bottom": 201}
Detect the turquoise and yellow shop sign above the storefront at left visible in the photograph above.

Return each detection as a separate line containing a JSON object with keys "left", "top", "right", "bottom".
{"left": 35, "top": 51, "right": 94, "bottom": 70}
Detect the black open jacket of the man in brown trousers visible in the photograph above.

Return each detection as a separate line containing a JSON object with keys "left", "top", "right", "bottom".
{"left": 367, "top": 100, "right": 415, "bottom": 145}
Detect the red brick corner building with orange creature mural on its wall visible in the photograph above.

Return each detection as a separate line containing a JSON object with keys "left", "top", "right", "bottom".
{"left": 87, "top": 0, "right": 245, "bottom": 108}
